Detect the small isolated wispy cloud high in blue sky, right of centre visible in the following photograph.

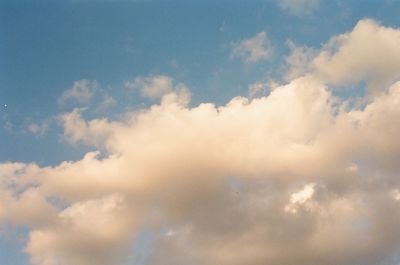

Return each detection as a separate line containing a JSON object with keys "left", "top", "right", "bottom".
{"left": 231, "top": 31, "right": 273, "bottom": 63}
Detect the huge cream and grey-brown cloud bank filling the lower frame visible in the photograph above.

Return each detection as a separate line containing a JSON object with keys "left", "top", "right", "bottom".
{"left": 0, "top": 19, "right": 400, "bottom": 265}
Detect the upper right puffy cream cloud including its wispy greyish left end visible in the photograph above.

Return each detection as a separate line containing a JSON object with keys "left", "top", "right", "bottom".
{"left": 286, "top": 19, "right": 400, "bottom": 92}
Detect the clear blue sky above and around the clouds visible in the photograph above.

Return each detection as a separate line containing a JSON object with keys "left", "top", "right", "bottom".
{"left": 0, "top": 0, "right": 400, "bottom": 265}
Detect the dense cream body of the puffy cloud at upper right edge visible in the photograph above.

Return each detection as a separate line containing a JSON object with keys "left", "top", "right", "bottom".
{"left": 313, "top": 20, "right": 400, "bottom": 91}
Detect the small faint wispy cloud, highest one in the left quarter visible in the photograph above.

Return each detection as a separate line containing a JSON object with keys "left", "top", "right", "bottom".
{"left": 58, "top": 79, "right": 98, "bottom": 106}
